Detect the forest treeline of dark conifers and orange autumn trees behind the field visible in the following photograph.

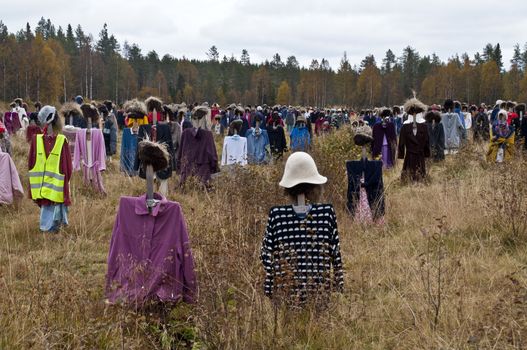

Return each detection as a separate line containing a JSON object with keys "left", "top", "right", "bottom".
{"left": 0, "top": 18, "right": 527, "bottom": 108}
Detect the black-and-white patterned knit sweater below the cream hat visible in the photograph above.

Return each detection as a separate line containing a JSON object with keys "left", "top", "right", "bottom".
{"left": 261, "top": 204, "right": 344, "bottom": 302}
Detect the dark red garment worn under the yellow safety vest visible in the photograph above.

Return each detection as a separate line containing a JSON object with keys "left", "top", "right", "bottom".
{"left": 28, "top": 135, "right": 73, "bottom": 207}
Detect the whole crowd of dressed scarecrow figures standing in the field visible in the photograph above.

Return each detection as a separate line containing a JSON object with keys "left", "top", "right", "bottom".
{"left": 0, "top": 96, "right": 527, "bottom": 306}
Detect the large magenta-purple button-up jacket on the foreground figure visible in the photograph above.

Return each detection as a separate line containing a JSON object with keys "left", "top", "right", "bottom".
{"left": 106, "top": 193, "right": 197, "bottom": 305}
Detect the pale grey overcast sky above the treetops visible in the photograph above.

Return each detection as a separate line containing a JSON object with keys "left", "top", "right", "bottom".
{"left": 0, "top": 0, "right": 527, "bottom": 68}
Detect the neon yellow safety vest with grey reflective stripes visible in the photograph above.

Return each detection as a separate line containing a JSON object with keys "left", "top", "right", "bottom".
{"left": 29, "top": 135, "right": 66, "bottom": 203}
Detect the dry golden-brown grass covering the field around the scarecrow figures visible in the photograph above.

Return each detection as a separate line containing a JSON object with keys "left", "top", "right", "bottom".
{"left": 0, "top": 131, "right": 527, "bottom": 349}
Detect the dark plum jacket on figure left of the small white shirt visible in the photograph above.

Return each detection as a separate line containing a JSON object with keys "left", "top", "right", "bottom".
{"left": 177, "top": 128, "right": 218, "bottom": 184}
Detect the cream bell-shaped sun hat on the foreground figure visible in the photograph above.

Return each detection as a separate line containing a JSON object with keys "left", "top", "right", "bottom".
{"left": 279, "top": 152, "right": 328, "bottom": 188}
